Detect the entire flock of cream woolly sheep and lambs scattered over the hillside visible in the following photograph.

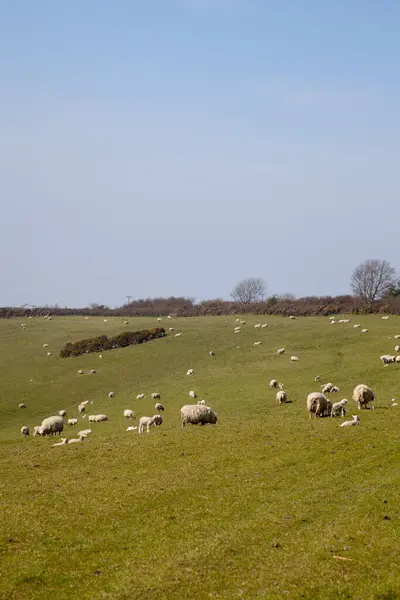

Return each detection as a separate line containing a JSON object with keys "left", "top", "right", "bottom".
{"left": 19, "top": 316, "right": 400, "bottom": 446}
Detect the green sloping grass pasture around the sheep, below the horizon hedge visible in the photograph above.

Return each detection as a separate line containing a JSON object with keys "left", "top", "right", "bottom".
{"left": 0, "top": 316, "right": 400, "bottom": 600}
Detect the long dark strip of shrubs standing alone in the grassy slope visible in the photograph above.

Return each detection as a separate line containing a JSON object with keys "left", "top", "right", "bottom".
{"left": 60, "top": 327, "right": 167, "bottom": 358}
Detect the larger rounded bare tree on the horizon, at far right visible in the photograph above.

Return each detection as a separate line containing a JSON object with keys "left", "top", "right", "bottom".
{"left": 351, "top": 259, "right": 396, "bottom": 304}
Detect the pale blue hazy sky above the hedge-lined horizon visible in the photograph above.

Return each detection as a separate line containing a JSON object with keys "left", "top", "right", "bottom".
{"left": 0, "top": 0, "right": 400, "bottom": 306}
